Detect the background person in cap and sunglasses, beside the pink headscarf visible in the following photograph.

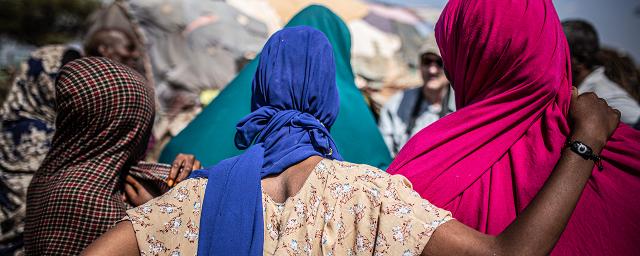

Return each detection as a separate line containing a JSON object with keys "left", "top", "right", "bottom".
{"left": 378, "top": 37, "right": 455, "bottom": 156}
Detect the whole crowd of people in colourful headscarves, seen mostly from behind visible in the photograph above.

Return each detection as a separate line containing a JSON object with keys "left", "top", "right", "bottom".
{"left": 0, "top": 0, "right": 640, "bottom": 255}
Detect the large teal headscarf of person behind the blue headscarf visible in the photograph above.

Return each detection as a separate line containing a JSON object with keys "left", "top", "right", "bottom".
{"left": 160, "top": 5, "right": 391, "bottom": 169}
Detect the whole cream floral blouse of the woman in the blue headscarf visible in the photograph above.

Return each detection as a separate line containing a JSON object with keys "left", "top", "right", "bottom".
{"left": 125, "top": 159, "right": 452, "bottom": 255}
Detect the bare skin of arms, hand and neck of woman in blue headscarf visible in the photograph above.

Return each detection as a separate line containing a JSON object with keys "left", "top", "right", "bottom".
{"left": 83, "top": 88, "right": 620, "bottom": 255}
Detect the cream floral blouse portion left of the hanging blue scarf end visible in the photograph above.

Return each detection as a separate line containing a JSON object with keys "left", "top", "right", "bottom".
{"left": 125, "top": 179, "right": 207, "bottom": 256}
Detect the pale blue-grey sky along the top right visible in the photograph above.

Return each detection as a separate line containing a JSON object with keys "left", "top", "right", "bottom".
{"left": 378, "top": 0, "right": 640, "bottom": 60}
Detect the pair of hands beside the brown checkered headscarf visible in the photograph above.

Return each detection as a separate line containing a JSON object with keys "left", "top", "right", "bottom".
{"left": 122, "top": 154, "right": 202, "bottom": 206}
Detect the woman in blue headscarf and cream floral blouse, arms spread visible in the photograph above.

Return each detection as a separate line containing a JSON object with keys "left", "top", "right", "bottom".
{"left": 84, "top": 26, "right": 620, "bottom": 255}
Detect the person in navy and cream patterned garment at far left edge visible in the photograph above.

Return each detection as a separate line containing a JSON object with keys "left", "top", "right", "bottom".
{"left": 0, "top": 45, "right": 80, "bottom": 255}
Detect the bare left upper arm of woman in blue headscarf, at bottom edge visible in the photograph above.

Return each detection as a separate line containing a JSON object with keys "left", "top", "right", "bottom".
{"left": 81, "top": 221, "right": 140, "bottom": 256}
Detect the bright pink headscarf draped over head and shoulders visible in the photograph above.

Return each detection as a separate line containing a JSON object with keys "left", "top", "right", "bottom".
{"left": 388, "top": 0, "right": 640, "bottom": 255}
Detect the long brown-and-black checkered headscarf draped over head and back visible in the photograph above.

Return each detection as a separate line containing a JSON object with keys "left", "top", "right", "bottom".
{"left": 25, "top": 58, "right": 154, "bottom": 255}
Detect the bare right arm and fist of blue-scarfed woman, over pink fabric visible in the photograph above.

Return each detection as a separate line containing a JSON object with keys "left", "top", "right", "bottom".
{"left": 422, "top": 89, "right": 620, "bottom": 255}
